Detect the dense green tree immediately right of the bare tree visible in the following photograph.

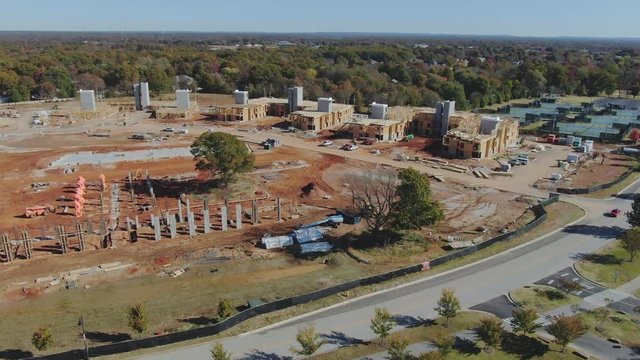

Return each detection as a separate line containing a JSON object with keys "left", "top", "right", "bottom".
{"left": 392, "top": 168, "right": 444, "bottom": 230}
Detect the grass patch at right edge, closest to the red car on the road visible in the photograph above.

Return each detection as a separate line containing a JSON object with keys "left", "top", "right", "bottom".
{"left": 576, "top": 240, "right": 640, "bottom": 288}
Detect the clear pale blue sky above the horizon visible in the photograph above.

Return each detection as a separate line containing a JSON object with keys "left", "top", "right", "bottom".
{"left": 5, "top": 0, "right": 640, "bottom": 38}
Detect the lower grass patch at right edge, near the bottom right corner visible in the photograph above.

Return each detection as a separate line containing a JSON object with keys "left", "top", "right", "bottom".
{"left": 579, "top": 311, "right": 640, "bottom": 348}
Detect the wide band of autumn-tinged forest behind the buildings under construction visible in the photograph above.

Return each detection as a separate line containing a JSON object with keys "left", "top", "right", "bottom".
{"left": 0, "top": 39, "right": 640, "bottom": 110}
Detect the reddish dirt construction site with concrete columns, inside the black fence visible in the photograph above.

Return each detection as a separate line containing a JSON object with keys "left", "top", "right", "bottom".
{"left": 0, "top": 87, "right": 625, "bottom": 349}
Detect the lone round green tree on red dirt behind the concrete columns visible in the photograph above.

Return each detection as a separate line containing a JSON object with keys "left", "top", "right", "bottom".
{"left": 191, "top": 132, "right": 255, "bottom": 187}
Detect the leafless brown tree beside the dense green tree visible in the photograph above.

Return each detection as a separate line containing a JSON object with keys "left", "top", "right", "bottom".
{"left": 347, "top": 170, "right": 398, "bottom": 232}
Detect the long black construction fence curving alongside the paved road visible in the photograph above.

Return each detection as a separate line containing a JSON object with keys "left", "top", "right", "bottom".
{"left": 34, "top": 194, "right": 559, "bottom": 360}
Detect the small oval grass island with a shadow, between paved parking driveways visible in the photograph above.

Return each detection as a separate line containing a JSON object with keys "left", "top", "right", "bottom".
{"left": 510, "top": 286, "right": 580, "bottom": 313}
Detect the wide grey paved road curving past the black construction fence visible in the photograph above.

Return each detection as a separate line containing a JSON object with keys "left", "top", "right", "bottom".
{"left": 143, "top": 180, "right": 640, "bottom": 359}
